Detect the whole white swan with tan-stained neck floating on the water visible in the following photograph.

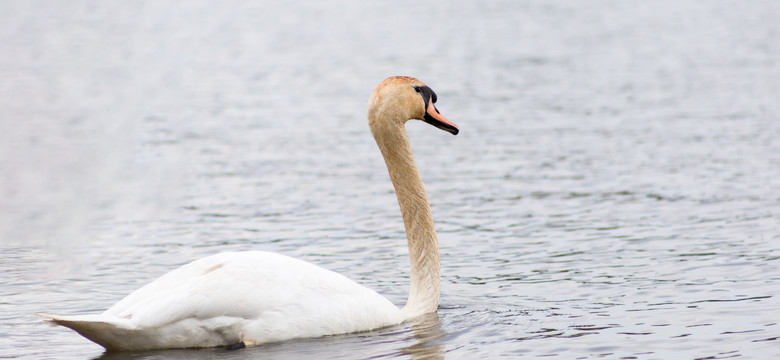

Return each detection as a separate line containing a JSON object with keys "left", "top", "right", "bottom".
{"left": 37, "top": 76, "right": 459, "bottom": 351}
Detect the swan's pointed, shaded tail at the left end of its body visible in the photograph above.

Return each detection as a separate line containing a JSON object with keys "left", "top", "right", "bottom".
{"left": 35, "top": 313, "right": 142, "bottom": 350}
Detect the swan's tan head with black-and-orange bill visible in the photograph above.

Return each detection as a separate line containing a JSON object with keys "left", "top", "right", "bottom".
{"left": 368, "top": 76, "right": 459, "bottom": 135}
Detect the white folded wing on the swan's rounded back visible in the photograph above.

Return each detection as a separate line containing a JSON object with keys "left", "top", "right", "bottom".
{"left": 94, "top": 251, "right": 403, "bottom": 347}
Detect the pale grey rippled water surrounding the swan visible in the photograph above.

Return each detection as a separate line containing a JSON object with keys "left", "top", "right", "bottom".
{"left": 0, "top": 1, "right": 780, "bottom": 359}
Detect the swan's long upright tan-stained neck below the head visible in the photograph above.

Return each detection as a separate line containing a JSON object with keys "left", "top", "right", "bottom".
{"left": 372, "top": 121, "right": 441, "bottom": 317}
